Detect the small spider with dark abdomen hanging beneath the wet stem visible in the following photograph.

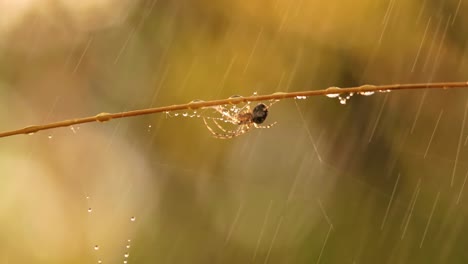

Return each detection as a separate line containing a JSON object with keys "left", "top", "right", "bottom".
{"left": 203, "top": 103, "right": 276, "bottom": 139}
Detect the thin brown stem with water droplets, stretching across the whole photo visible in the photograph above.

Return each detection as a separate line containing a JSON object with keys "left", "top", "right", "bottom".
{"left": 0, "top": 82, "right": 468, "bottom": 138}
